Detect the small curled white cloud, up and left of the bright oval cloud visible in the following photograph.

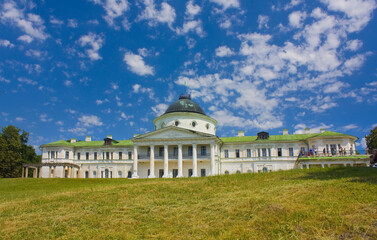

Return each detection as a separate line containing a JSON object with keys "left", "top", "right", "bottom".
{"left": 78, "top": 33, "right": 104, "bottom": 61}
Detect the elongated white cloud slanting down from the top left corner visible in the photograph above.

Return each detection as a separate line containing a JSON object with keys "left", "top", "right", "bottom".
{"left": 0, "top": 0, "right": 48, "bottom": 41}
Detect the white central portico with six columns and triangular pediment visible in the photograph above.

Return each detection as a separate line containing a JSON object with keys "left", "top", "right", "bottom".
{"left": 132, "top": 126, "right": 220, "bottom": 178}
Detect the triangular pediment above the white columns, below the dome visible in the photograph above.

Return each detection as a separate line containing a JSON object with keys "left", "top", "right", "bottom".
{"left": 134, "top": 126, "right": 214, "bottom": 140}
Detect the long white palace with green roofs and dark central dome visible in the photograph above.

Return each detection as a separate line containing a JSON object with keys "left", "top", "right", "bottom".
{"left": 22, "top": 95, "right": 365, "bottom": 178}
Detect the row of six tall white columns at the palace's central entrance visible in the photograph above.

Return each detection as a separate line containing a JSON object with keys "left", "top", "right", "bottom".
{"left": 132, "top": 144, "right": 215, "bottom": 178}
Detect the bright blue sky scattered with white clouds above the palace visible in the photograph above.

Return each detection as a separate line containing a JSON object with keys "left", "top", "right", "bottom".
{"left": 0, "top": 0, "right": 377, "bottom": 152}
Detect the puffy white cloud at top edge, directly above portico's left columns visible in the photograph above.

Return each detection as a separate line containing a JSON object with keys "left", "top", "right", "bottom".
{"left": 139, "top": 0, "right": 176, "bottom": 27}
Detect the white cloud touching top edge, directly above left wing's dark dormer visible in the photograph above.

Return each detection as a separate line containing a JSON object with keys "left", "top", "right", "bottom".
{"left": 92, "top": 0, "right": 129, "bottom": 27}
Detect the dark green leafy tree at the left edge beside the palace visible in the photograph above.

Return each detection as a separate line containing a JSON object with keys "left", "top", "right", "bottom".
{"left": 0, "top": 125, "right": 41, "bottom": 177}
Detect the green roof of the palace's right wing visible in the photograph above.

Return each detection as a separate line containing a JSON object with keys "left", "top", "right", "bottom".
{"left": 220, "top": 131, "right": 354, "bottom": 143}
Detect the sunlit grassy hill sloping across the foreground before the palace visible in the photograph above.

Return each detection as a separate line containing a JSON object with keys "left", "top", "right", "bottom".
{"left": 0, "top": 167, "right": 377, "bottom": 239}
